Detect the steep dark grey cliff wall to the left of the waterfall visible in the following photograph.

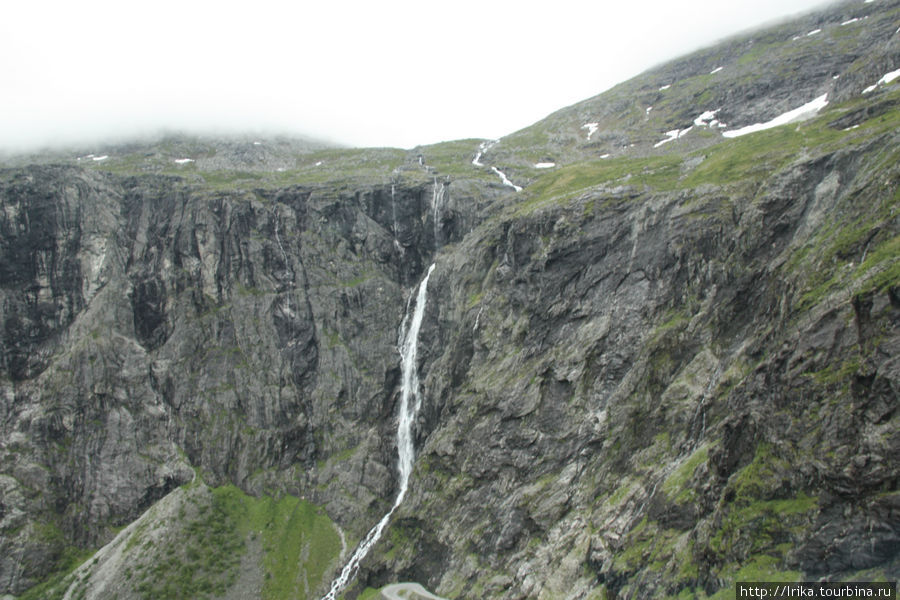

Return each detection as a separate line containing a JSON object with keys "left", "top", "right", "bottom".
{"left": 0, "top": 161, "right": 500, "bottom": 592}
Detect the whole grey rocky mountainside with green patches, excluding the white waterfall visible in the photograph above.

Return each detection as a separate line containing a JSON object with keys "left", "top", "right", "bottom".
{"left": 0, "top": 1, "right": 900, "bottom": 598}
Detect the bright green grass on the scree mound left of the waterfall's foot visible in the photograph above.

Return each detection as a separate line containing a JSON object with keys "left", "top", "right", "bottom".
{"left": 59, "top": 485, "right": 341, "bottom": 600}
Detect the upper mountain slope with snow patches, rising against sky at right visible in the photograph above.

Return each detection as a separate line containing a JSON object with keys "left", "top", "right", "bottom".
{"left": 493, "top": 0, "right": 900, "bottom": 175}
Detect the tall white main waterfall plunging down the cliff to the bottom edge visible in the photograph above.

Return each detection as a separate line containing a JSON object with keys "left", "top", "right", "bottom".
{"left": 322, "top": 265, "right": 434, "bottom": 600}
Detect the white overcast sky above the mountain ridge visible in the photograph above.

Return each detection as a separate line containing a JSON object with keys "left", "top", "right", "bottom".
{"left": 0, "top": 0, "right": 832, "bottom": 150}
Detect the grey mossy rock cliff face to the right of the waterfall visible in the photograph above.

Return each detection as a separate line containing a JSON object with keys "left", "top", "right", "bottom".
{"left": 384, "top": 134, "right": 900, "bottom": 597}
